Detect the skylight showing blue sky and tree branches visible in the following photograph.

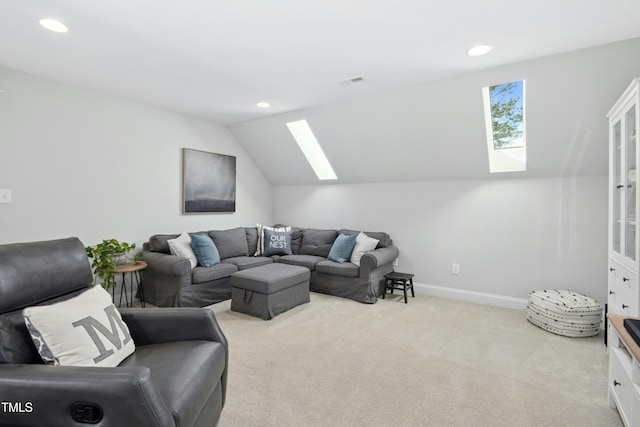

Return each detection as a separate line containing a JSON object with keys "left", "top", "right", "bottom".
{"left": 482, "top": 80, "right": 527, "bottom": 173}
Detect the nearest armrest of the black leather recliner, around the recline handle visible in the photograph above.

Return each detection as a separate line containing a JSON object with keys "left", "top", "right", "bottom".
{"left": 0, "top": 364, "right": 175, "bottom": 427}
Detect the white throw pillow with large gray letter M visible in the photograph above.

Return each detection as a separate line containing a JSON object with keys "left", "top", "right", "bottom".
{"left": 22, "top": 286, "right": 135, "bottom": 367}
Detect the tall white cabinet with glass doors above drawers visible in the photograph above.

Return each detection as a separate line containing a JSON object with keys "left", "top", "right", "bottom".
{"left": 607, "top": 78, "right": 640, "bottom": 316}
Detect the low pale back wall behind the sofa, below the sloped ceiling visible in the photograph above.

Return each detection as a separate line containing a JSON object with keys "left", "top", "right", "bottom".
{"left": 273, "top": 176, "right": 608, "bottom": 305}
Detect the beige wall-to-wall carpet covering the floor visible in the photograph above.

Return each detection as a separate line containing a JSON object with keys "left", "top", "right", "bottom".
{"left": 212, "top": 293, "right": 622, "bottom": 427}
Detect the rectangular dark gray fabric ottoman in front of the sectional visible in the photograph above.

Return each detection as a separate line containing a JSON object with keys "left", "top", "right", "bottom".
{"left": 231, "top": 263, "right": 311, "bottom": 320}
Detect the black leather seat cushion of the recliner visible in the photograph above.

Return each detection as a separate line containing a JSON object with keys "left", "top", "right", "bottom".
{"left": 120, "top": 341, "right": 225, "bottom": 426}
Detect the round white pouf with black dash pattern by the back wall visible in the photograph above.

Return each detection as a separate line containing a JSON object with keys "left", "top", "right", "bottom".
{"left": 527, "top": 289, "right": 602, "bottom": 337}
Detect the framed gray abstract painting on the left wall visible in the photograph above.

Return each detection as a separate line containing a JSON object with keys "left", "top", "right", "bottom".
{"left": 182, "top": 148, "right": 236, "bottom": 214}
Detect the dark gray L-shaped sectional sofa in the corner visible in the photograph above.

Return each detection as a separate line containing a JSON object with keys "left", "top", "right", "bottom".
{"left": 142, "top": 227, "right": 399, "bottom": 307}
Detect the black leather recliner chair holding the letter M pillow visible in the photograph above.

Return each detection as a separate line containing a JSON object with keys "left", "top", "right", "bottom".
{"left": 0, "top": 238, "right": 229, "bottom": 427}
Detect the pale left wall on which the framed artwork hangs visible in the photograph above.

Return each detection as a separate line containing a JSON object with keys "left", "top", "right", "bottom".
{"left": 0, "top": 68, "right": 272, "bottom": 245}
